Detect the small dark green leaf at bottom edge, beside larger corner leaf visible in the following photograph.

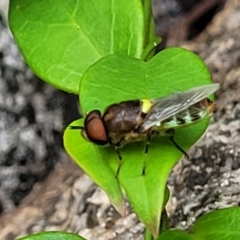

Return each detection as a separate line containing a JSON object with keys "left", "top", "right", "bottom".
{"left": 157, "top": 230, "right": 197, "bottom": 240}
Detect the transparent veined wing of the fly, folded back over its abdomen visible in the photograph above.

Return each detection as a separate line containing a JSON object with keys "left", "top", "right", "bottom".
{"left": 141, "top": 83, "right": 219, "bottom": 131}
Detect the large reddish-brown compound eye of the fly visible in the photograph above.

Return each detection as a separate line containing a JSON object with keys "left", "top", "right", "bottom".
{"left": 83, "top": 110, "right": 108, "bottom": 145}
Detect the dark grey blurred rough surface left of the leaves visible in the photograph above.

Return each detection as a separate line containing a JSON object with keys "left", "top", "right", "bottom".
{"left": 0, "top": 16, "right": 78, "bottom": 217}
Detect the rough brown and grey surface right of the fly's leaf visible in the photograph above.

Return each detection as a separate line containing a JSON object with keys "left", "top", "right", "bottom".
{"left": 170, "top": 0, "right": 240, "bottom": 228}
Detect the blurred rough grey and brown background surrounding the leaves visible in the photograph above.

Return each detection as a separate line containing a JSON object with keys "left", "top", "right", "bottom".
{"left": 0, "top": 0, "right": 240, "bottom": 240}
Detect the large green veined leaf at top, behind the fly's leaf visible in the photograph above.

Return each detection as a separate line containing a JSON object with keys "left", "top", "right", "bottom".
{"left": 9, "top": 0, "right": 146, "bottom": 93}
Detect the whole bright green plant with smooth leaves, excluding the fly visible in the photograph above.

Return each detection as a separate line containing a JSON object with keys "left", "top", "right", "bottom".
{"left": 9, "top": 0, "right": 240, "bottom": 240}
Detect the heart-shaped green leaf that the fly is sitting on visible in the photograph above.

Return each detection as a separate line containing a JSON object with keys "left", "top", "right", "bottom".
{"left": 65, "top": 48, "right": 211, "bottom": 236}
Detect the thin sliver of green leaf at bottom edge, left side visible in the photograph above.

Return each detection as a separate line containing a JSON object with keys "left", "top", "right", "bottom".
{"left": 18, "top": 232, "right": 85, "bottom": 240}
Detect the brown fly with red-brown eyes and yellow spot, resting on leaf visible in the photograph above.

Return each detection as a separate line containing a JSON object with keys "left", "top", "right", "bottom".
{"left": 70, "top": 84, "right": 219, "bottom": 176}
